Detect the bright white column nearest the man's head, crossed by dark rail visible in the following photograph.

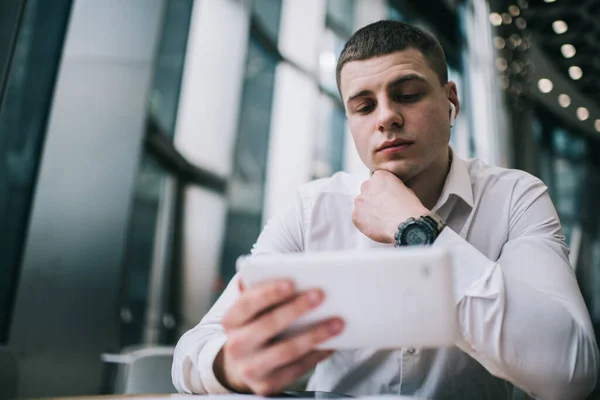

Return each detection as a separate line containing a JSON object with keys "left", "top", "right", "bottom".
{"left": 263, "top": 0, "right": 326, "bottom": 221}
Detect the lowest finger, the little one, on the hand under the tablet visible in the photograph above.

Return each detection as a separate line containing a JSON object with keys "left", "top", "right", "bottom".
{"left": 250, "top": 351, "right": 333, "bottom": 396}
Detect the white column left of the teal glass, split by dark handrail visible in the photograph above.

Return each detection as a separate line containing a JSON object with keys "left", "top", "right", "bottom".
{"left": 175, "top": 0, "right": 251, "bottom": 330}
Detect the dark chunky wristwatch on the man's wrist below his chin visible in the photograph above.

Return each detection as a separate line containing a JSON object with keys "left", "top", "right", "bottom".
{"left": 394, "top": 213, "right": 446, "bottom": 247}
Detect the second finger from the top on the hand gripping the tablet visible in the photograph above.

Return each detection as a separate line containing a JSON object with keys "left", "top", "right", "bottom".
{"left": 240, "top": 289, "right": 324, "bottom": 349}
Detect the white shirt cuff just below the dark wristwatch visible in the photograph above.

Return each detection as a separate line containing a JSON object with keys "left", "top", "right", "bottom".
{"left": 433, "top": 227, "right": 496, "bottom": 304}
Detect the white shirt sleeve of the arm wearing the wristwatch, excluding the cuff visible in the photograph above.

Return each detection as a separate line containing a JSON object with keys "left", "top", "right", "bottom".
{"left": 435, "top": 180, "right": 599, "bottom": 400}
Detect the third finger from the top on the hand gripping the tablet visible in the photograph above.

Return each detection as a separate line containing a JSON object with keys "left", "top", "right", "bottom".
{"left": 250, "top": 318, "right": 344, "bottom": 379}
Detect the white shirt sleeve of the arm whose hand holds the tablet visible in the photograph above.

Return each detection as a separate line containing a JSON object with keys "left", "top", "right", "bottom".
{"left": 171, "top": 192, "right": 306, "bottom": 394}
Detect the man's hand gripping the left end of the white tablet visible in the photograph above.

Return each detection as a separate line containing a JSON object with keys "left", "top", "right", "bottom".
{"left": 214, "top": 279, "right": 344, "bottom": 395}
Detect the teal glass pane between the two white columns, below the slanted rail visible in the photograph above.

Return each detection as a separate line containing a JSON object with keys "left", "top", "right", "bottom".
{"left": 221, "top": 34, "right": 277, "bottom": 282}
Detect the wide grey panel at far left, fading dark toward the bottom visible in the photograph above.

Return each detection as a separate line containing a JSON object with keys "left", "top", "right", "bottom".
{"left": 8, "top": 0, "right": 165, "bottom": 398}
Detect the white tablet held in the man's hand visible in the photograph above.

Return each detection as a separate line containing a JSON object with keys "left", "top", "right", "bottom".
{"left": 237, "top": 247, "right": 458, "bottom": 349}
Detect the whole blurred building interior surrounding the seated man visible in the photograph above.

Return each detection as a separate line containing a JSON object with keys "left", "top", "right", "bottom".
{"left": 0, "top": 0, "right": 600, "bottom": 398}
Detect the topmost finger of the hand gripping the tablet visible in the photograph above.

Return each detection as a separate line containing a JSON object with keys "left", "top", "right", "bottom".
{"left": 221, "top": 280, "right": 294, "bottom": 331}
